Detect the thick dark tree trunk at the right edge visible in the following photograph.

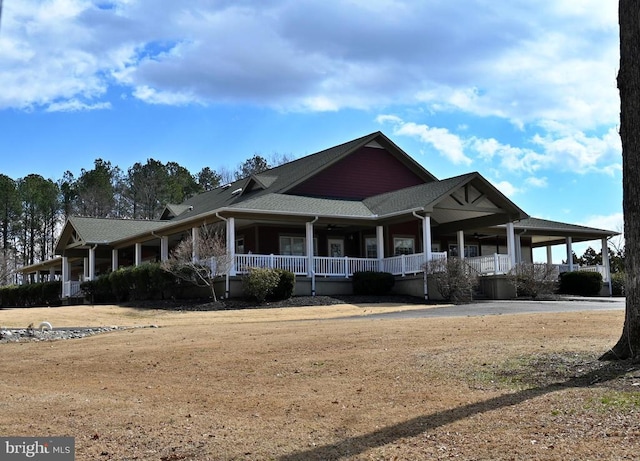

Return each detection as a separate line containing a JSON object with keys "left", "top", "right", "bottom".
{"left": 601, "top": 0, "right": 640, "bottom": 360}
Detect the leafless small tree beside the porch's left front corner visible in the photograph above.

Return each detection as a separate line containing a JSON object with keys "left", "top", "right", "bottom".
{"left": 162, "top": 226, "right": 231, "bottom": 301}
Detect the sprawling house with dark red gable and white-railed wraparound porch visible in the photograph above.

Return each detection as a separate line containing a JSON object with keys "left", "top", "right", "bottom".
{"left": 22, "top": 132, "right": 617, "bottom": 298}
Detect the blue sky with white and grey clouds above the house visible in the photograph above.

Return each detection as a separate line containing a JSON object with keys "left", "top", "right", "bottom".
{"left": 0, "top": 0, "right": 622, "bottom": 255}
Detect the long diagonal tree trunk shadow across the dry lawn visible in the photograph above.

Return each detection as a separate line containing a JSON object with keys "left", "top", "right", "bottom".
{"left": 278, "top": 361, "right": 640, "bottom": 461}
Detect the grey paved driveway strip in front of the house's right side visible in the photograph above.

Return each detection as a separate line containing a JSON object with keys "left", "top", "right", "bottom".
{"left": 350, "top": 298, "right": 625, "bottom": 319}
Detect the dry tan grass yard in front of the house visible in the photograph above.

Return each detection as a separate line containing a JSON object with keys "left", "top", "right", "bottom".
{"left": 0, "top": 305, "right": 640, "bottom": 461}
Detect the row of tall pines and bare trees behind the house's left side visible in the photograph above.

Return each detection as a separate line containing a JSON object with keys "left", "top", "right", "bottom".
{"left": 0, "top": 154, "right": 293, "bottom": 285}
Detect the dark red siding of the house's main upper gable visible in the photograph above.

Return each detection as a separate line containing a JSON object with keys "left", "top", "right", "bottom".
{"left": 289, "top": 147, "right": 424, "bottom": 200}
